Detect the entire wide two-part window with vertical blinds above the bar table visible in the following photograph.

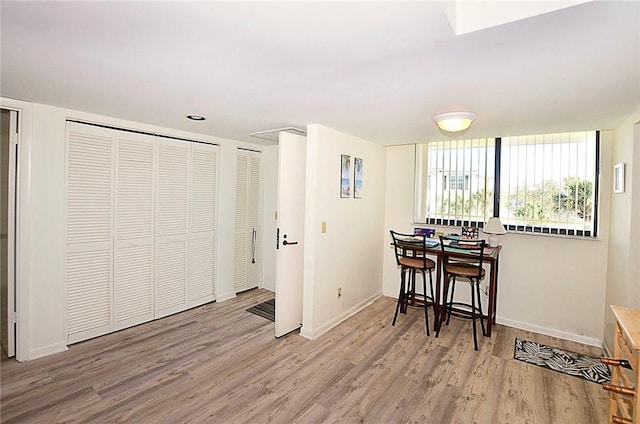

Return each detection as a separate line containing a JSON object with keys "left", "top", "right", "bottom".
{"left": 415, "top": 131, "right": 599, "bottom": 237}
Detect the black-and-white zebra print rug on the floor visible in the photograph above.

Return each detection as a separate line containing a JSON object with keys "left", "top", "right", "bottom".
{"left": 513, "top": 337, "right": 611, "bottom": 384}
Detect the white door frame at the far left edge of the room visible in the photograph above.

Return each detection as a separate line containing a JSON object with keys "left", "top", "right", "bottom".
{"left": 0, "top": 97, "right": 33, "bottom": 362}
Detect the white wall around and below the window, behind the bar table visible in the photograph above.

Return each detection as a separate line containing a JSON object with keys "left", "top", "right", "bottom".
{"left": 383, "top": 131, "right": 612, "bottom": 346}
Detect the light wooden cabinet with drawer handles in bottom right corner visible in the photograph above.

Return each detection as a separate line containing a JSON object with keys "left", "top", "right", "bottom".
{"left": 603, "top": 306, "right": 640, "bottom": 424}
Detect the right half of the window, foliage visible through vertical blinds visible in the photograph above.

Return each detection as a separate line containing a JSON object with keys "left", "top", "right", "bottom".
{"left": 499, "top": 131, "right": 597, "bottom": 236}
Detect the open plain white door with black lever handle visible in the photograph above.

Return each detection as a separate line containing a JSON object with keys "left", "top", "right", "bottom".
{"left": 275, "top": 132, "right": 307, "bottom": 337}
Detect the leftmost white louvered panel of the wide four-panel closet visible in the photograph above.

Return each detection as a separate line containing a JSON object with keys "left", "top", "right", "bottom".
{"left": 65, "top": 123, "right": 114, "bottom": 343}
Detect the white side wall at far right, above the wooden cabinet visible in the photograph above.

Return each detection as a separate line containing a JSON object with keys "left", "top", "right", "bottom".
{"left": 604, "top": 110, "right": 640, "bottom": 352}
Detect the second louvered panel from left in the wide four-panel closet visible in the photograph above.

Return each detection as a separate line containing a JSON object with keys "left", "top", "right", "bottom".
{"left": 114, "top": 132, "right": 156, "bottom": 330}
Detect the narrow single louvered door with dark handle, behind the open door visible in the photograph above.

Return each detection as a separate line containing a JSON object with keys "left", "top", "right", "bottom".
{"left": 234, "top": 150, "right": 262, "bottom": 292}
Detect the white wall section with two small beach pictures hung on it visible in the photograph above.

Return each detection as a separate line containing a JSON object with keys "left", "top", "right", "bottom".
{"left": 301, "top": 124, "right": 385, "bottom": 338}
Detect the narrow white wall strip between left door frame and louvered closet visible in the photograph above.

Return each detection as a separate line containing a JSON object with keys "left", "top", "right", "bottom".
{"left": 27, "top": 104, "right": 66, "bottom": 359}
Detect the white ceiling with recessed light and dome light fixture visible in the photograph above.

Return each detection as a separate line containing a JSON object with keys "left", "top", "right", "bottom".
{"left": 0, "top": 0, "right": 640, "bottom": 145}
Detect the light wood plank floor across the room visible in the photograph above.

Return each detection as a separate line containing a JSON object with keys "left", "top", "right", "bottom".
{"left": 0, "top": 290, "right": 607, "bottom": 424}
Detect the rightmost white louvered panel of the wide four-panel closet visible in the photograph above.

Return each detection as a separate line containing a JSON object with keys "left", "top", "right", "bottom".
{"left": 189, "top": 143, "right": 218, "bottom": 307}
